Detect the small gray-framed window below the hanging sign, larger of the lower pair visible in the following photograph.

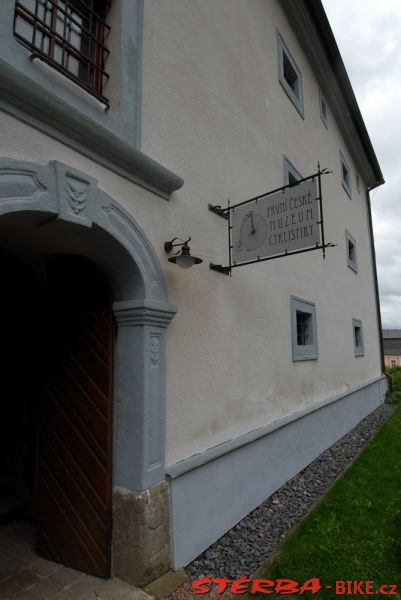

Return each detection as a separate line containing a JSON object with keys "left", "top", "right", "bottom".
{"left": 291, "top": 296, "right": 318, "bottom": 361}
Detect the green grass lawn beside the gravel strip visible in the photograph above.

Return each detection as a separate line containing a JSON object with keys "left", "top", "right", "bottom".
{"left": 256, "top": 407, "right": 401, "bottom": 599}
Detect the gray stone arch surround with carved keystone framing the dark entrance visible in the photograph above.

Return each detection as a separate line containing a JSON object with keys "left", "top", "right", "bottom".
{"left": 0, "top": 159, "right": 175, "bottom": 585}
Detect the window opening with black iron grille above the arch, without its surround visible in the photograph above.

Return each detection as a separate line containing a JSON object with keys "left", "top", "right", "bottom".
{"left": 14, "top": 0, "right": 110, "bottom": 106}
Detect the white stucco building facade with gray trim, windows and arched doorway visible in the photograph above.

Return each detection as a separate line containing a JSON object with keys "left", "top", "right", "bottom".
{"left": 0, "top": 0, "right": 386, "bottom": 585}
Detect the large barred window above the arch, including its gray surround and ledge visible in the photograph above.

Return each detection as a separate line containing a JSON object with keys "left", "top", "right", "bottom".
{"left": 0, "top": 0, "right": 145, "bottom": 188}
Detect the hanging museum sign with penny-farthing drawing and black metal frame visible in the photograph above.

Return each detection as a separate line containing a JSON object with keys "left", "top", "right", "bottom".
{"left": 209, "top": 169, "right": 334, "bottom": 274}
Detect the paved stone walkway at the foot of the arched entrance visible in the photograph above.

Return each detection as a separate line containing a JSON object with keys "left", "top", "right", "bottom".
{"left": 0, "top": 521, "right": 151, "bottom": 600}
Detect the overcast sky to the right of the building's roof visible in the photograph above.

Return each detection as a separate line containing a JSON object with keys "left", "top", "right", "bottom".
{"left": 323, "top": 0, "right": 401, "bottom": 329}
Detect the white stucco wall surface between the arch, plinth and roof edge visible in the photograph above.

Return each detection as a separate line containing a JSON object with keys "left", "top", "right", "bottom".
{"left": 0, "top": 0, "right": 380, "bottom": 463}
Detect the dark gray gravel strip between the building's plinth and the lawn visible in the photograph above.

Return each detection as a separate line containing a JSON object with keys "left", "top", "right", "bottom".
{"left": 184, "top": 404, "right": 395, "bottom": 580}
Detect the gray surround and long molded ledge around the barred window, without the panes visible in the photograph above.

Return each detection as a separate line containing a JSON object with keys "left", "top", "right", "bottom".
{"left": 0, "top": 0, "right": 184, "bottom": 199}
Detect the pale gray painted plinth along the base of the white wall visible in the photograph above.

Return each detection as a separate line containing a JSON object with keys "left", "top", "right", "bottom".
{"left": 167, "top": 378, "right": 386, "bottom": 569}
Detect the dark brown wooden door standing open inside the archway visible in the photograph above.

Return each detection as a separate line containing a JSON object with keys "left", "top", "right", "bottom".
{"left": 38, "top": 257, "right": 113, "bottom": 577}
